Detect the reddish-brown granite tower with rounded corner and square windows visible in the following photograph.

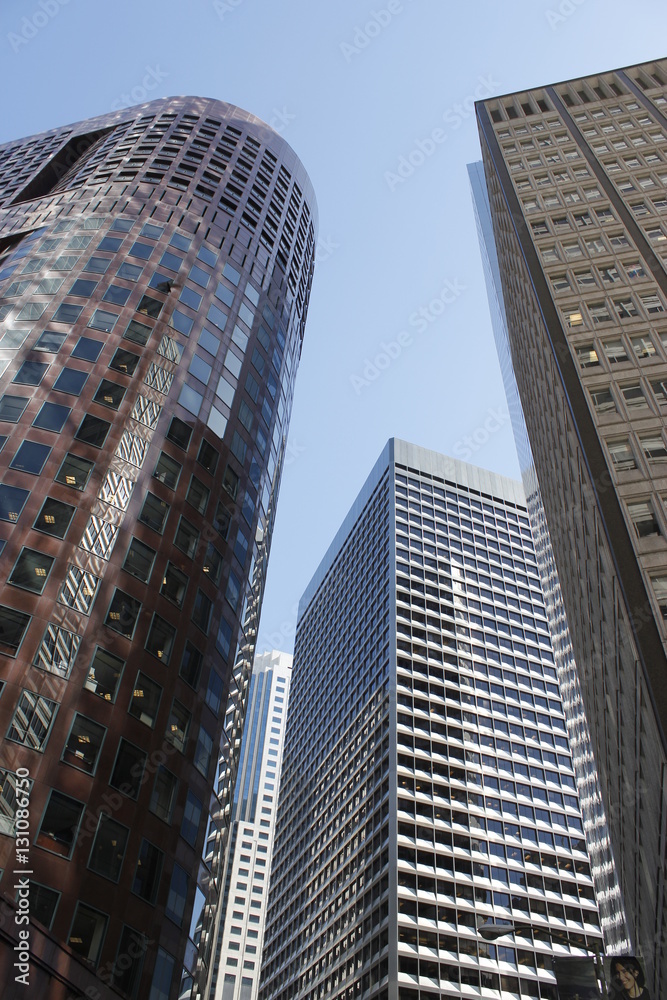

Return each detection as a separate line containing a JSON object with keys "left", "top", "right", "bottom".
{"left": 0, "top": 98, "right": 316, "bottom": 1000}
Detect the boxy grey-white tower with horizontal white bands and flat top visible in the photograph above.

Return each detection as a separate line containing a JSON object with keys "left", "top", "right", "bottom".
{"left": 260, "top": 440, "right": 601, "bottom": 1000}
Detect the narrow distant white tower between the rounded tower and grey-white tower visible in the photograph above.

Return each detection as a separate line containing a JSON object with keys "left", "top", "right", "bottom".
{"left": 210, "top": 652, "right": 292, "bottom": 1000}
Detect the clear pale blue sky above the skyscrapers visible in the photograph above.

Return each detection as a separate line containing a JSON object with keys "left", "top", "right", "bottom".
{"left": 0, "top": 0, "right": 667, "bottom": 652}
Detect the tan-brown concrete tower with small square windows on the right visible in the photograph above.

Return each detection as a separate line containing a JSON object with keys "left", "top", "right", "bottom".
{"left": 477, "top": 60, "right": 667, "bottom": 995}
